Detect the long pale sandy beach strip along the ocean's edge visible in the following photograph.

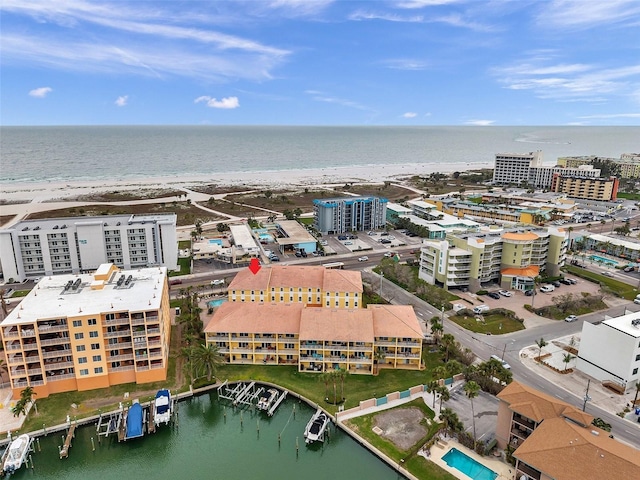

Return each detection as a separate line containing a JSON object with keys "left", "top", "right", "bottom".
{"left": 0, "top": 162, "right": 493, "bottom": 202}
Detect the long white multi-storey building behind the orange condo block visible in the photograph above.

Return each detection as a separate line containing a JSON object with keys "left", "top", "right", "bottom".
{"left": 0, "top": 214, "right": 178, "bottom": 281}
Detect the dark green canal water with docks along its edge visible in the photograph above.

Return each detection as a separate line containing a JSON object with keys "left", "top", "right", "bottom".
{"left": 11, "top": 392, "right": 399, "bottom": 480}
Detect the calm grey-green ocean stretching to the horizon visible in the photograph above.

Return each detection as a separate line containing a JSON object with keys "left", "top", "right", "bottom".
{"left": 0, "top": 126, "right": 640, "bottom": 183}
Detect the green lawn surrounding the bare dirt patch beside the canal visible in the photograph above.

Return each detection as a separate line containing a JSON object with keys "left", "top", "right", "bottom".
{"left": 345, "top": 399, "right": 456, "bottom": 480}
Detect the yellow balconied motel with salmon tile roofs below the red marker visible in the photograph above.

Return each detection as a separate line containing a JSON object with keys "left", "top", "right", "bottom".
{"left": 205, "top": 266, "right": 423, "bottom": 375}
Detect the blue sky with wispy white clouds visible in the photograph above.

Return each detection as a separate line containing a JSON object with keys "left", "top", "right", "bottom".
{"left": 0, "top": 0, "right": 640, "bottom": 126}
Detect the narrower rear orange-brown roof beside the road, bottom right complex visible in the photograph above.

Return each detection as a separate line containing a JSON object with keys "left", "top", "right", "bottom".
{"left": 498, "top": 382, "right": 593, "bottom": 425}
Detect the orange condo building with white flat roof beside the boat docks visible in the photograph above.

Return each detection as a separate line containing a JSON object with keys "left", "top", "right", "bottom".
{"left": 0, "top": 264, "right": 171, "bottom": 398}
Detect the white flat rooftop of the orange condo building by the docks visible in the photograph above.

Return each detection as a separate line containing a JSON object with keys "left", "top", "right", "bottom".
{"left": 0, "top": 266, "right": 167, "bottom": 327}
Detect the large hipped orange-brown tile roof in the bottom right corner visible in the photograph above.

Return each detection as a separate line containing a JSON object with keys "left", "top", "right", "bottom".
{"left": 514, "top": 418, "right": 640, "bottom": 480}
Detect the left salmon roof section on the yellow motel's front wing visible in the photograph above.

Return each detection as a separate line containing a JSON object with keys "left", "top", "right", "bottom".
{"left": 204, "top": 302, "right": 303, "bottom": 333}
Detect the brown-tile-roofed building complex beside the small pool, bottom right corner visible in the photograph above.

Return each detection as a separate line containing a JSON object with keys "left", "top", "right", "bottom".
{"left": 496, "top": 382, "right": 640, "bottom": 480}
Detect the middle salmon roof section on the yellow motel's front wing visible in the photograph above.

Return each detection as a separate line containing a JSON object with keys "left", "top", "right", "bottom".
{"left": 300, "top": 307, "right": 374, "bottom": 343}
